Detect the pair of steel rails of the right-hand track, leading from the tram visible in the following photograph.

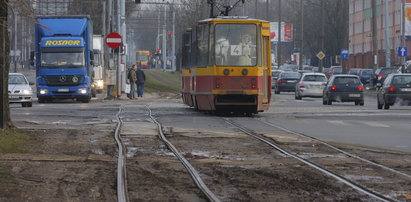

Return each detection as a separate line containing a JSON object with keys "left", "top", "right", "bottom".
{"left": 224, "top": 118, "right": 409, "bottom": 201}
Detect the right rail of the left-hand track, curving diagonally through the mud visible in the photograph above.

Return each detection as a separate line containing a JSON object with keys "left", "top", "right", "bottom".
{"left": 146, "top": 105, "right": 220, "bottom": 202}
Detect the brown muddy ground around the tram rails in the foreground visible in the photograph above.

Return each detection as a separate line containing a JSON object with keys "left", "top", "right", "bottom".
{"left": 0, "top": 95, "right": 411, "bottom": 201}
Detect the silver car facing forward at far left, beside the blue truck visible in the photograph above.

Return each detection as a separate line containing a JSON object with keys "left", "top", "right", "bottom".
{"left": 9, "top": 73, "right": 33, "bottom": 107}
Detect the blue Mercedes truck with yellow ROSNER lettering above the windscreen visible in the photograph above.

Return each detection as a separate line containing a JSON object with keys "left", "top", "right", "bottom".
{"left": 32, "top": 16, "right": 94, "bottom": 103}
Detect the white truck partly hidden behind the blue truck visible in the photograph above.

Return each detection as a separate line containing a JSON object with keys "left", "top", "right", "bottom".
{"left": 92, "top": 35, "right": 106, "bottom": 97}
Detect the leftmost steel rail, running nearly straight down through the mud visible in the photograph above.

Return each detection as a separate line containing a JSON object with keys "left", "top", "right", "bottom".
{"left": 114, "top": 105, "right": 127, "bottom": 202}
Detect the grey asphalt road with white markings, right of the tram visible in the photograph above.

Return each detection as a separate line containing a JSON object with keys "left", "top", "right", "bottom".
{"left": 259, "top": 90, "right": 411, "bottom": 152}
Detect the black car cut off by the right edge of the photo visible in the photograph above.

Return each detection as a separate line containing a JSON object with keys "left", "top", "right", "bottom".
{"left": 377, "top": 74, "right": 411, "bottom": 109}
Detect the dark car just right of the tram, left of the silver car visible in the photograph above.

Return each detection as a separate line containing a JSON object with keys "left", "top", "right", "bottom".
{"left": 274, "top": 72, "right": 301, "bottom": 94}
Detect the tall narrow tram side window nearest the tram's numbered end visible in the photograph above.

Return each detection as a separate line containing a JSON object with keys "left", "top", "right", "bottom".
{"left": 197, "top": 24, "right": 209, "bottom": 67}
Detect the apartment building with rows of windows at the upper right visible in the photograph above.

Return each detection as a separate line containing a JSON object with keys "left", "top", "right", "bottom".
{"left": 349, "top": 0, "right": 411, "bottom": 68}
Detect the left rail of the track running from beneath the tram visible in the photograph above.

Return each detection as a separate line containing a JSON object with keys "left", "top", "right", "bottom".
{"left": 225, "top": 118, "right": 394, "bottom": 201}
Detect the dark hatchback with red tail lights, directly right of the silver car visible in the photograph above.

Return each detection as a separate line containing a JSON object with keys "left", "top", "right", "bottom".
{"left": 323, "top": 74, "right": 364, "bottom": 106}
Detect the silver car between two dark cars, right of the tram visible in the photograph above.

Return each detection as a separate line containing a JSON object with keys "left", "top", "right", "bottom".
{"left": 295, "top": 73, "right": 327, "bottom": 100}
